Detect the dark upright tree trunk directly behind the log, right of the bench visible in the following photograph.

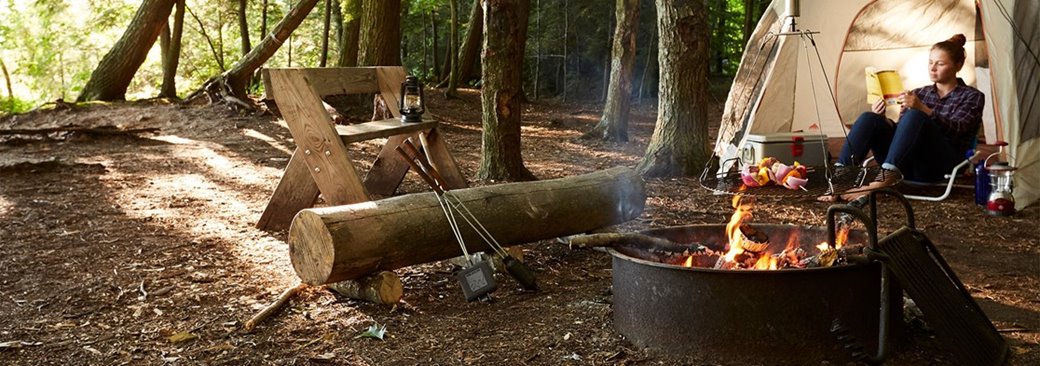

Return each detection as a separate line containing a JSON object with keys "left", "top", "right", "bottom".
{"left": 476, "top": 0, "right": 535, "bottom": 181}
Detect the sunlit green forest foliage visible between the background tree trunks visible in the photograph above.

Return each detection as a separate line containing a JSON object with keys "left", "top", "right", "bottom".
{"left": 0, "top": 0, "right": 769, "bottom": 115}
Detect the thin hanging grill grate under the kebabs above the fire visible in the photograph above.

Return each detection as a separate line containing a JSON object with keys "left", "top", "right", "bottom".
{"left": 700, "top": 165, "right": 881, "bottom": 198}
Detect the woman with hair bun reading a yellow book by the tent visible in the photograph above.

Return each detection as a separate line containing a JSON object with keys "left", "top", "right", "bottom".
{"left": 825, "top": 34, "right": 985, "bottom": 201}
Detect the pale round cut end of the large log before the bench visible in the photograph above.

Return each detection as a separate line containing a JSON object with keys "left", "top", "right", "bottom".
{"left": 289, "top": 210, "right": 336, "bottom": 286}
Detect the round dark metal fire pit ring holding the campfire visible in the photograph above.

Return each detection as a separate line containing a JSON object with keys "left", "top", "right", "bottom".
{"left": 609, "top": 225, "right": 902, "bottom": 365}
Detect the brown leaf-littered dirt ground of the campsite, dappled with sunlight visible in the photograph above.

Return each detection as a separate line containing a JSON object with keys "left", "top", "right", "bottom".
{"left": 0, "top": 90, "right": 1040, "bottom": 365}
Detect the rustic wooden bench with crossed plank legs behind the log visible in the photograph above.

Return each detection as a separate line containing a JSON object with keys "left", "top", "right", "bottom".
{"left": 257, "top": 67, "right": 466, "bottom": 230}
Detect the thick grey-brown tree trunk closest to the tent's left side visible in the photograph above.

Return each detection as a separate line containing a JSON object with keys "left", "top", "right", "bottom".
{"left": 639, "top": 0, "right": 708, "bottom": 177}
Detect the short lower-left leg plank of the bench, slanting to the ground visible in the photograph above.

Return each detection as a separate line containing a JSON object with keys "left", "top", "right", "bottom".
{"left": 257, "top": 149, "right": 318, "bottom": 231}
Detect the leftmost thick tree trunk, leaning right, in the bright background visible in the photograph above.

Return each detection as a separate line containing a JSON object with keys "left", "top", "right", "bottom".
{"left": 77, "top": 0, "right": 175, "bottom": 102}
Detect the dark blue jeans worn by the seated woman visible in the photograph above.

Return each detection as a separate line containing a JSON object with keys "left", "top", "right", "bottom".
{"left": 838, "top": 109, "right": 965, "bottom": 182}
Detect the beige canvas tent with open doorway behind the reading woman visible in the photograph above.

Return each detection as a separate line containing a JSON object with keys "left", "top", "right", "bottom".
{"left": 714, "top": 0, "right": 1040, "bottom": 208}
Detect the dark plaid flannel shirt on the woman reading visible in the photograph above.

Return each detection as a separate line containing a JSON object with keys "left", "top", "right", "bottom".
{"left": 913, "top": 78, "right": 986, "bottom": 151}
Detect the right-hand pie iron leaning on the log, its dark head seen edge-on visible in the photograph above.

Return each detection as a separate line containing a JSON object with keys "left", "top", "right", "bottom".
{"left": 401, "top": 137, "right": 538, "bottom": 291}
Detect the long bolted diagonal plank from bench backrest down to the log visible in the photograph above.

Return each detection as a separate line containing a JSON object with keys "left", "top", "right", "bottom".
{"left": 270, "top": 69, "right": 368, "bottom": 205}
